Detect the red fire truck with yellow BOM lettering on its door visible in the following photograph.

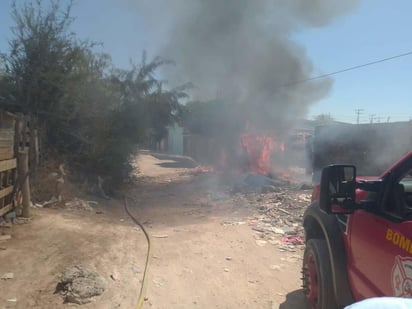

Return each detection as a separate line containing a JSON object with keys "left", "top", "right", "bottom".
{"left": 302, "top": 150, "right": 412, "bottom": 309}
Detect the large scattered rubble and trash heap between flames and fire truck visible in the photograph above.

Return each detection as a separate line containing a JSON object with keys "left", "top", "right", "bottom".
{"left": 227, "top": 179, "right": 312, "bottom": 252}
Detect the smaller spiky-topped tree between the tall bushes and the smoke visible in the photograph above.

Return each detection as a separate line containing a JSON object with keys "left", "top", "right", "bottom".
{"left": 108, "top": 52, "right": 191, "bottom": 141}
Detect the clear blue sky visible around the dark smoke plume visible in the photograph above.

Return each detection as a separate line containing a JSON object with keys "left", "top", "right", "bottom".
{"left": 0, "top": 0, "right": 412, "bottom": 122}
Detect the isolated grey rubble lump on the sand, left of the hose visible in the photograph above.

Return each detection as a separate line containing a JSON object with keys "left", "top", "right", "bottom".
{"left": 56, "top": 266, "right": 106, "bottom": 305}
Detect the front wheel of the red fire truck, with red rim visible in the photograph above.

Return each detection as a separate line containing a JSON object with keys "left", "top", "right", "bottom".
{"left": 302, "top": 239, "right": 337, "bottom": 309}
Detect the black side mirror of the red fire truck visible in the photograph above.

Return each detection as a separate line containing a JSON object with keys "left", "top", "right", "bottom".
{"left": 319, "top": 165, "right": 356, "bottom": 214}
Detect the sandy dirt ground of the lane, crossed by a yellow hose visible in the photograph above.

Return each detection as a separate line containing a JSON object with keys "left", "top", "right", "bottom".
{"left": 0, "top": 154, "right": 305, "bottom": 309}
